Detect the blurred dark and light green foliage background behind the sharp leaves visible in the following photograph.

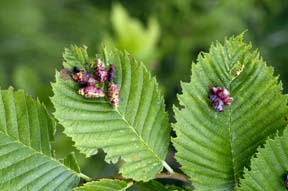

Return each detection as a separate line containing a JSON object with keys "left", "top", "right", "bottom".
{"left": 0, "top": 0, "right": 288, "bottom": 182}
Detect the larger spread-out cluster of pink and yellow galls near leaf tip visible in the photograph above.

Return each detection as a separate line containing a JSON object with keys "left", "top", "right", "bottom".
{"left": 61, "top": 59, "right": 119, "bottom": 107}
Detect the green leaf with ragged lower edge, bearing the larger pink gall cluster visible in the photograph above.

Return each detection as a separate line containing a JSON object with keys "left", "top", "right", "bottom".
{"left": 52, "top": 46, "right": 170, "bottom": 181}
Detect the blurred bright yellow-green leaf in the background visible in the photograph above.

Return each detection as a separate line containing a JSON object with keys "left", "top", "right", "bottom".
{"left": 111, "top": 3, "right": 160, "bottom": 66}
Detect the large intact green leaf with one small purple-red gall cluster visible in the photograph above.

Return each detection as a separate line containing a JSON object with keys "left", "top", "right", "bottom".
{"left": 173, "top": 34, "right": 288, "bottom": 191}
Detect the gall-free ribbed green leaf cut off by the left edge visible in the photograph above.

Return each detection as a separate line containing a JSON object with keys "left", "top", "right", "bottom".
{"left": 0, "top": 88, "right": 79, "bottom": 191}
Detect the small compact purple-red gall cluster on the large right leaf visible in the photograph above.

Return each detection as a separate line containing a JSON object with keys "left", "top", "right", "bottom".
{"left": 209, "top": 86, "right": 233, "bottom": 112}
